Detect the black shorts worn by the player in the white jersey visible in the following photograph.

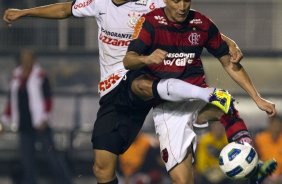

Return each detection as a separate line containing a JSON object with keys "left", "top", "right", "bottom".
{"left": 91, "top": 71, "right": 152, "bottom": 155}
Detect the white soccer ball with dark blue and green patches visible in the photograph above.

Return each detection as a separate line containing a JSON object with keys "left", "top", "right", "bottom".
{"left": 219, "top": 142, "right": 258, "bottom": 179}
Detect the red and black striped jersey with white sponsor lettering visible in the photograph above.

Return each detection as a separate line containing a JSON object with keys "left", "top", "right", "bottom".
{"left": 128, "top": 8, "right": 229, "bottom": 86}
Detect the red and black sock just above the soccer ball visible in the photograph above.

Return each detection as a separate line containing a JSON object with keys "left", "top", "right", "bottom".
{"left": 220, "top": 109, "right": 252, "bottom": 144}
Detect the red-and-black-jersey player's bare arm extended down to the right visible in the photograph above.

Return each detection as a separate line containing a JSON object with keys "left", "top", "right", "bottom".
{"left": 219, "top": 55, "right": 276, "bottom": 117}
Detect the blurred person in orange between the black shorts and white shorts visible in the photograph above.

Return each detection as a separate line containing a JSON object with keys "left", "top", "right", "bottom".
{"left": 119, "top": 132, "right": 167, "bottom": 184}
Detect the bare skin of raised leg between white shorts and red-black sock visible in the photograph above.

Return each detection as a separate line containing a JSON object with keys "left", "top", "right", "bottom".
{"left": 197, "top": 104, "right": 224, "bottom": 124}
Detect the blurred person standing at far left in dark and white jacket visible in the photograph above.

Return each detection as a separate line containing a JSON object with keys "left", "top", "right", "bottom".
{"left": 1, "top": 49, "right": 72, "bottom": 184}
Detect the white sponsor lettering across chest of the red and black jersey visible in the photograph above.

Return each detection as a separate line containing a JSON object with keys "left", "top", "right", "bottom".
{"left": 163, "top": 52, "right": 195, "bottom": 66}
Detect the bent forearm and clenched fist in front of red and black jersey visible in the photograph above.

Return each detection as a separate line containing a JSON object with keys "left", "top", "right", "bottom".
{"left": 123, "top": 49, "right": 167, "bottom": 70}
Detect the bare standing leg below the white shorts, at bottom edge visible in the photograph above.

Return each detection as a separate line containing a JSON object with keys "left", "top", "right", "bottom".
{"left": 169, "top": 146, "right": 194, "bottom": 184}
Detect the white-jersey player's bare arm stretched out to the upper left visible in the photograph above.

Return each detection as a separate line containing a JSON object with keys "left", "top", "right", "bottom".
{"left": 3, "top": 2, "right": 72, "bottom": 24}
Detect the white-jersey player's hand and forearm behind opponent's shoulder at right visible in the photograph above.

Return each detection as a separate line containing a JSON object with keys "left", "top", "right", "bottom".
{"left": 221, "top": 33, "right": 243, "bottom": 63}
